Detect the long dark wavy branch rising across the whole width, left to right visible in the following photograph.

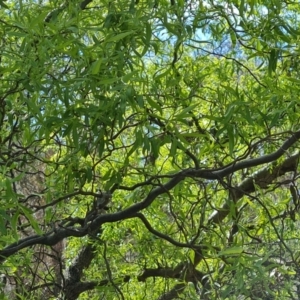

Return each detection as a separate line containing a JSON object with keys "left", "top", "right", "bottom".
{"left": 0, "top": 131, "right": 300, "bottom": 262}
